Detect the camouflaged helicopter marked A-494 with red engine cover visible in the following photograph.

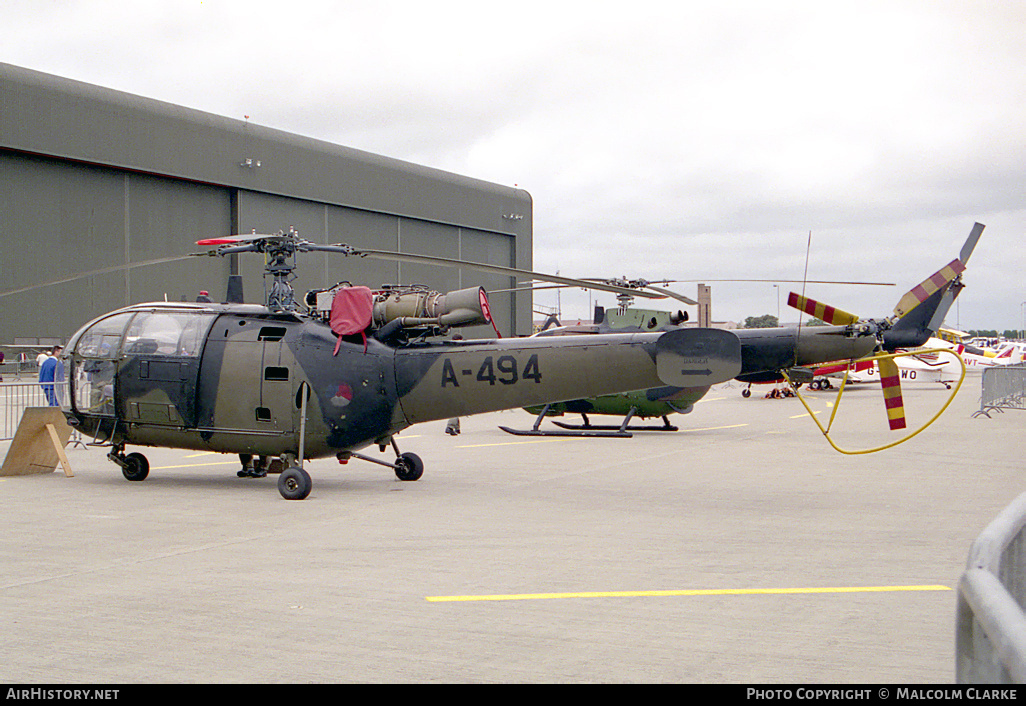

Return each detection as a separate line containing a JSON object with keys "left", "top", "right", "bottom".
{"left": 52, "top": 225, "right": 983, "bottom": 500}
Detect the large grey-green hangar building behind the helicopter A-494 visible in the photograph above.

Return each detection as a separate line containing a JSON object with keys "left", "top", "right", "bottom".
{"left": 0, "top": 64, "right": 532, "bottom": 345}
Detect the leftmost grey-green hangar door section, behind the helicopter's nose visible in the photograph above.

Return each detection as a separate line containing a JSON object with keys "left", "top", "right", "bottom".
{"left": 0, "top": 152, "right": 231, "bottom": 341}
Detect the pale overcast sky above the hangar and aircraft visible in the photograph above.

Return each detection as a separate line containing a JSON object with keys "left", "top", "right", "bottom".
{"left": 0, "top": 0, "right": 1026, "bottom": 329}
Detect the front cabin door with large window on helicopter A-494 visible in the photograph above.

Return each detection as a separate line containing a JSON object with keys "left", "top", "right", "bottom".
{"left": 118, "top": 310, "right": 215, "bottom": 428}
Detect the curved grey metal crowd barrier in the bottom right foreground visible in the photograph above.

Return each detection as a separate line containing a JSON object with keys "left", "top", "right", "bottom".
{"left": 955, "top": 493, "right": 1026, "bottom": 683}
